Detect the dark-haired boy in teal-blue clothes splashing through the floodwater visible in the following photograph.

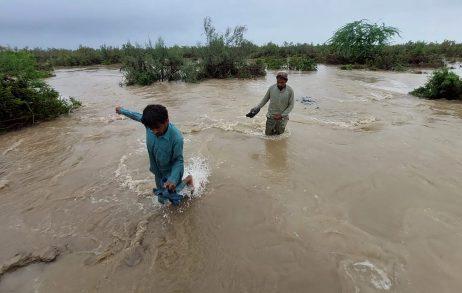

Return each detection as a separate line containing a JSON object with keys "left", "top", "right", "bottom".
{"left": 115, "top": 105, "right": 193, "bottom": 204}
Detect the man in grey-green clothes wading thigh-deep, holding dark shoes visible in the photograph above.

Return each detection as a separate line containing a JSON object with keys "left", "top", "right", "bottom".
{"left": 246, "top": 71, "right": 294, "bottom": 135}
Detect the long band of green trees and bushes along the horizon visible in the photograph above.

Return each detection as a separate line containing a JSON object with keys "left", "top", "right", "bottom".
{"left": 0, "top": 17, "right": 462, "bottom": 85}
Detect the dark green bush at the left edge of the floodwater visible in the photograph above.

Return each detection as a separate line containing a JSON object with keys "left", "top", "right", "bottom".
{"left": 0, "top": 51, "right": 80, "bottom": 131}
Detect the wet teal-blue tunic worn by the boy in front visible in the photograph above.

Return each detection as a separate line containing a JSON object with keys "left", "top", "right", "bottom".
{"left": 120, "top": 108, "right": 184, "bottom": 188}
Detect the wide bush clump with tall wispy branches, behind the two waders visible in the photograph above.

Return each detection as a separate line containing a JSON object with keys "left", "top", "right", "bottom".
{"left": 121, "top": 18, "right": 266, "bottom": 85}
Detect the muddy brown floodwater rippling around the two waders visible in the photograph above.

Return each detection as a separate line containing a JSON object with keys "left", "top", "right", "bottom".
{"left": 0, "top": 66, "right": 462, "bottom": 293}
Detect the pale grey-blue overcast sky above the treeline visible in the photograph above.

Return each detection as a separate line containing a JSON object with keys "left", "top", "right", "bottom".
{"left": 0, "top": 0, "right": 462, "bottom": 48}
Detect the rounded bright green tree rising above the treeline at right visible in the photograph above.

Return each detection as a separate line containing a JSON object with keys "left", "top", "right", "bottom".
{"left": 328, "top": 20, "right": 399, "bottom": 64}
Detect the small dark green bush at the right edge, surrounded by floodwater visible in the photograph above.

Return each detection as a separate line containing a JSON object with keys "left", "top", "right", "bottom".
{"left": 410, "top": 68, "right": 462, "bottom": 100}
